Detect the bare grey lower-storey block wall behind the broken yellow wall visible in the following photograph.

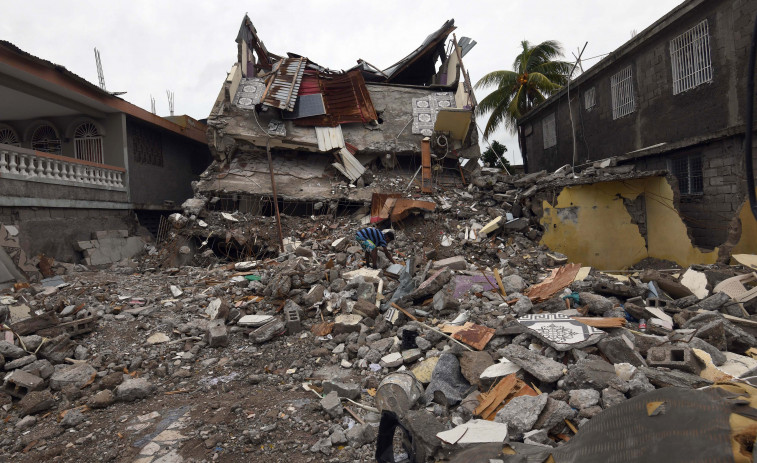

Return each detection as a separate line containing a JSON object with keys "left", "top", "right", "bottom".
{"left": 635, "top": 137, "right": 745, "bottom": 248}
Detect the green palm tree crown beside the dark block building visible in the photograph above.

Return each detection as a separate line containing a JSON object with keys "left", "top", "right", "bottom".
{"left": 476, "top": 40, "right": 571, "bottom": 138}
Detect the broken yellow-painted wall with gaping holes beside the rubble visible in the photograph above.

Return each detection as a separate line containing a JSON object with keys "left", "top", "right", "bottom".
{"left": 541, "top": 177, "right": 757, "bottom": 270}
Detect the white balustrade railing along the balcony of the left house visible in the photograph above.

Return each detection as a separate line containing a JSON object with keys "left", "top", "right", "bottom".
{"left": 0, "top": 144, "right": 126, "bottom": 189}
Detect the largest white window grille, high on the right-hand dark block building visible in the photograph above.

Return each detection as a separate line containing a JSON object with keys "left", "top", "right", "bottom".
{"left": 670, "top": 19, "right": 712, "bottom": 95}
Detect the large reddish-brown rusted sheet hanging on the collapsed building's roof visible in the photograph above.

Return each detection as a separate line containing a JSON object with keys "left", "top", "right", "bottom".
{"left": 294, "top": 70, "right": 378, "bottom": 127}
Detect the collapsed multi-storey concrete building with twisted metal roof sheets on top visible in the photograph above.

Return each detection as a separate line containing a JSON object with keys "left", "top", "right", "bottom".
{"left": 197, "top": 16, "right": 480, "bottom": 215}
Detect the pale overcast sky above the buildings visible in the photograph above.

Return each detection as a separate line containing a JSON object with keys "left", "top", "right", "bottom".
{"left": 0, "top": 0, "right": 680, "bottom": 164}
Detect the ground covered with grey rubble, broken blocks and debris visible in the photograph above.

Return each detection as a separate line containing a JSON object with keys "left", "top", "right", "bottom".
{"left": 0, "top": 169, "right": 757, "bottom": 463}
